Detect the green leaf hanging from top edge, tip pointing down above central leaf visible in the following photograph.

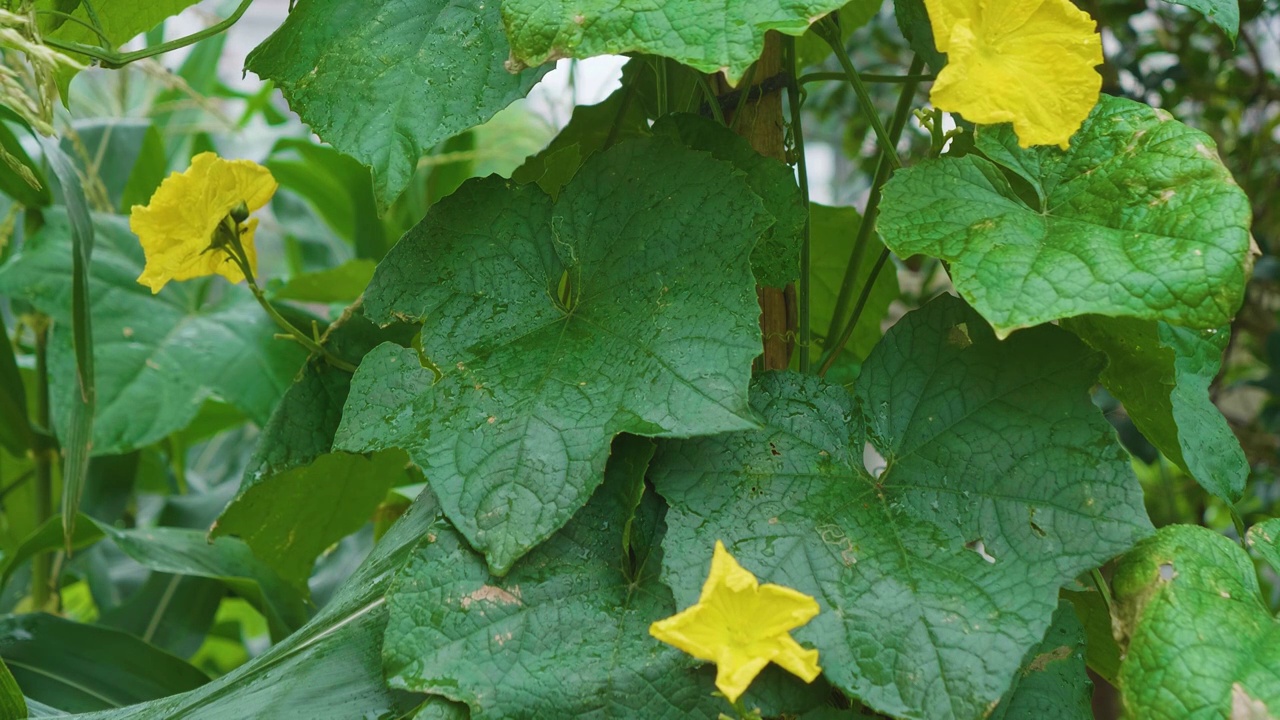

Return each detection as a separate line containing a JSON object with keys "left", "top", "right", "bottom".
{"left": 246, "top": 0, "right": 547, "bottom": 210}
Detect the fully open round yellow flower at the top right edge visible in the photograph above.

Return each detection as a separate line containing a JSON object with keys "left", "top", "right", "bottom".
{"left": 924, "top": 0, "right": 1102, "bottom": 150}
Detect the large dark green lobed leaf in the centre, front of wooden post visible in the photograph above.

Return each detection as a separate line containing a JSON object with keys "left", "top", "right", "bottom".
{"left": 334, "top": 140, "right": 771, "bottom": 574}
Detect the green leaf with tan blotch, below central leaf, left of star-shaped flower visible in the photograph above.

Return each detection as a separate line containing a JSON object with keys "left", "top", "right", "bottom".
{"left": 383, "top": 430, "right": 824, "bottom": 720}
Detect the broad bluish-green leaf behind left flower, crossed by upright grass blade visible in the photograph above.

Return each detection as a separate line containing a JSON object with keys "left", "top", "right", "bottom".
{"left": 0, "top": 213, "right": 305, "bottom": 455}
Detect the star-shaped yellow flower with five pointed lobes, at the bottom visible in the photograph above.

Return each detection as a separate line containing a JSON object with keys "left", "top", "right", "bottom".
{"left": 649, "top": 541, "right": 822, "bottom": 702}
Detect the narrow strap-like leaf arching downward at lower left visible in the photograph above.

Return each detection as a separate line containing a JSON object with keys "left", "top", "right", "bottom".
{"left": 102, "top": 525, "right": 307, "bottom": 641}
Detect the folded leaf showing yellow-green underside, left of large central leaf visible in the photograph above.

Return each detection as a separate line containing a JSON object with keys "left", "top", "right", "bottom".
{"left": 210, "top": 307, "right": 415, "bottom": 587}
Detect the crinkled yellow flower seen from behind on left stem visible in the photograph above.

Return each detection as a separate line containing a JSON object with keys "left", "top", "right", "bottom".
{"left": 129, "top": 152, "right": 279, "bottom": 292}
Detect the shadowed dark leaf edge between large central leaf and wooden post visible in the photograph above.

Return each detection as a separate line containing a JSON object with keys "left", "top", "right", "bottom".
{"left": 653, "top": 114, "right": 806, "bottom": 287}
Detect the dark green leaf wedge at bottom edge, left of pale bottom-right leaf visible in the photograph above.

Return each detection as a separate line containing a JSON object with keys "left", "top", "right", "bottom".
{"left": 988, "top": 601, "right": 1093, "bottom": 720}
